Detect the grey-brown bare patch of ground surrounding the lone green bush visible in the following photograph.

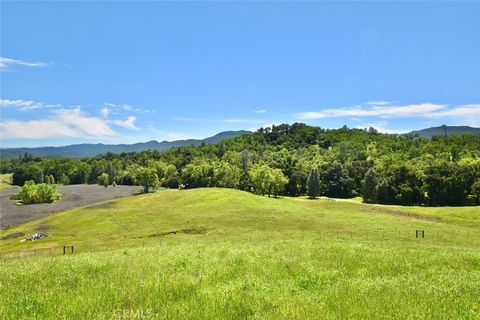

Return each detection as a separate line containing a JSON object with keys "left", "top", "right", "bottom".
{"left": 0, "top": 184, "right": 142, "bottom": 226}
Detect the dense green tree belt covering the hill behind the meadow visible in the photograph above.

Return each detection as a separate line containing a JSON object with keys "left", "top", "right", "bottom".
{"left": 1, "top": 123, "right": 480, "bottom": 206}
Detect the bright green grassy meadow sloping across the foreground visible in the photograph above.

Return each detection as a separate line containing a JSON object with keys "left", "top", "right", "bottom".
{"left": 0, "top": 188, "right": 480, "bottom": 319}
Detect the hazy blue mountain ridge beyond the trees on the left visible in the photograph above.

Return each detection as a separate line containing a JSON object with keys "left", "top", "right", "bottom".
{"left": 0, "top": 130, "right": 252, "bottom": 159}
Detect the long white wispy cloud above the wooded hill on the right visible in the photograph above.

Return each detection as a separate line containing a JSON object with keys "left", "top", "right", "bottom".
{"left": 296, "top": 101, "right": 480, "bottom": 125}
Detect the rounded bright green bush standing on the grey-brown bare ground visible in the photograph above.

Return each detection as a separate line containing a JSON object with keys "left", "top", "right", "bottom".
{"left": 11, "top": 180, "right": 61, "bottom": 204}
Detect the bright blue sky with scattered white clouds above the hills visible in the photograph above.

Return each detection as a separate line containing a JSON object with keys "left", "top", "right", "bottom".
{"left": 0, "top": 1, "right": 480, "bottom": 147}
